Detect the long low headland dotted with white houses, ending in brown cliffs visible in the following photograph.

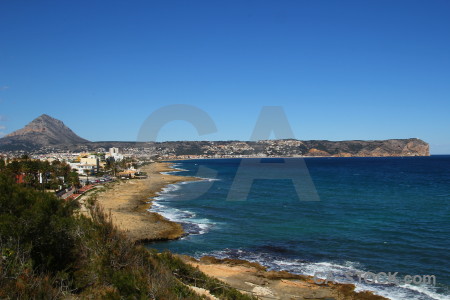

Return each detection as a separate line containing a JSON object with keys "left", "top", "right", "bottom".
{"left": 54, "top": 138, "right": 430, "bottom": 158}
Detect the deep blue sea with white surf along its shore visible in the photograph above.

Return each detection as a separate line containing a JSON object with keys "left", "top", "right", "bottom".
{"left": 149, "top": 156, "right": 450, "bottom": 299}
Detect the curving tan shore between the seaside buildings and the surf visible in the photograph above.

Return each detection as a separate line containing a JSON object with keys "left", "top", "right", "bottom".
{"left": 89, "top": 162, "right": 198, "bottom": 242}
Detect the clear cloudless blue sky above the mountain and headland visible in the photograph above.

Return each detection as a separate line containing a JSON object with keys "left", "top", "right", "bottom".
{"left": 0, "top": 0, "right": 450, "bottom": 154}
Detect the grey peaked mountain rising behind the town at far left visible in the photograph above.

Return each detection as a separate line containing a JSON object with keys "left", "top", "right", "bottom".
{"left": 0, "top": 114, "right": 89, "bottom": 150}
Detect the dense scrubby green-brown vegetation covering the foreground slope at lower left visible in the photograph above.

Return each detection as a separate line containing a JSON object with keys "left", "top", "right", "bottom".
{"left": 0, "top": 174, "right": 250, "bottom": 299}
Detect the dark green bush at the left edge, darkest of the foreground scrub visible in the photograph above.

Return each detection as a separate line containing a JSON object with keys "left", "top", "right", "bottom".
{"left": 0, "top": 172, "right": 76, "bottom": 272}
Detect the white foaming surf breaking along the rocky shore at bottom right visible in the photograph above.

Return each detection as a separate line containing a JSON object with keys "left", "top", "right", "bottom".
{"left": 200, "top": 249, "right": 450, "bottom": 300}
